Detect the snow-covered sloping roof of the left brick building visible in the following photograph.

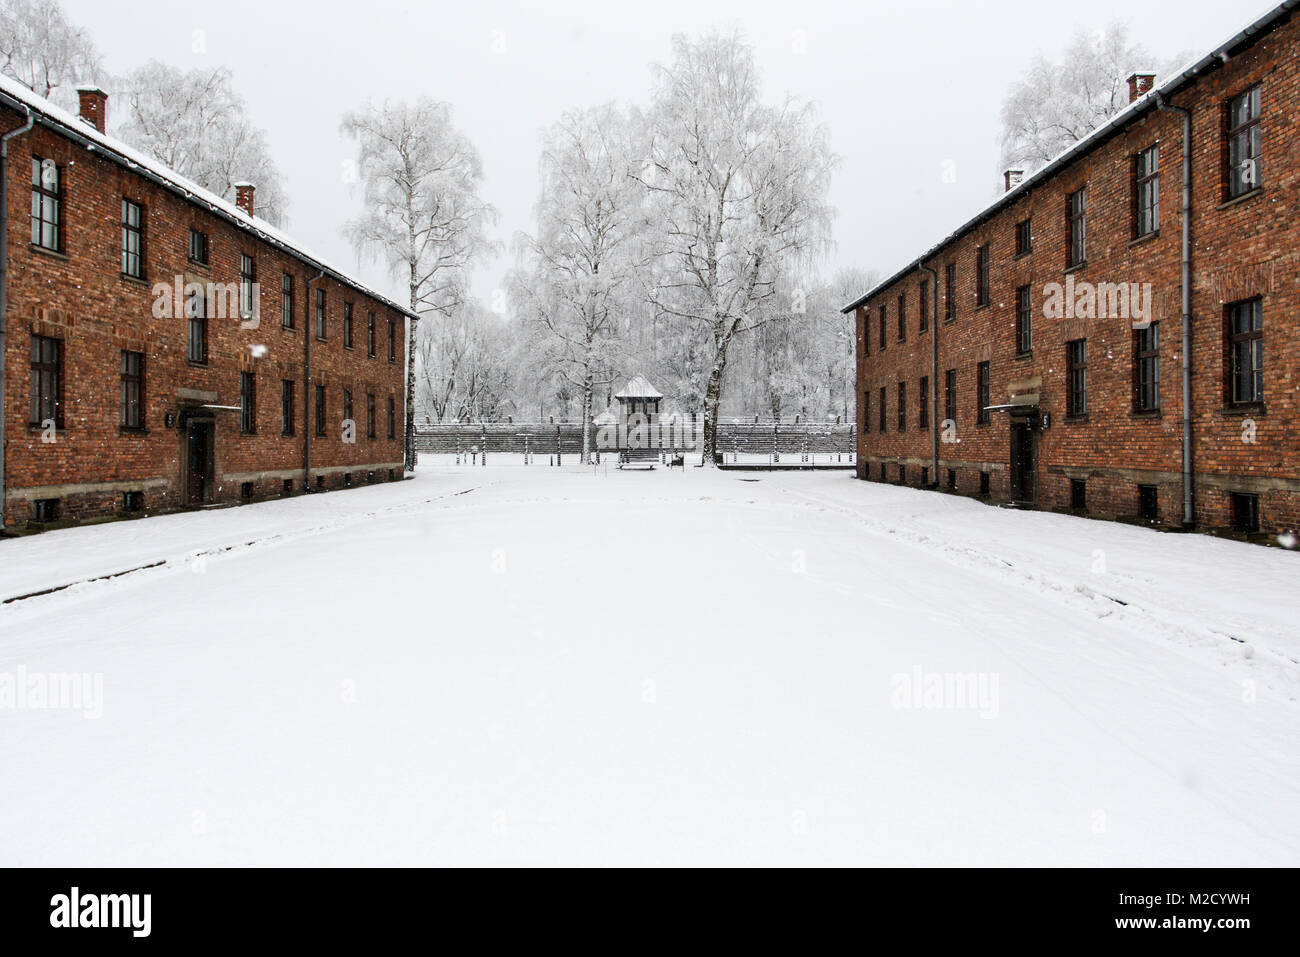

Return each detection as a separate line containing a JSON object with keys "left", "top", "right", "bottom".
{"left": 0, "top": 75, "right": 419, "bottom": 319}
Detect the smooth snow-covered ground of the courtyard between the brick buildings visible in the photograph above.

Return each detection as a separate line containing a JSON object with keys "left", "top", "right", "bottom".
{"left": 0, "top": 464, "right": 1300, "bottom": 866}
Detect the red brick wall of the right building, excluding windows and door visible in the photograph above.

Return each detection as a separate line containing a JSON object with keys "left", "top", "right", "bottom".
{"left": 857, "top": 9, "right": 1300, "bottom": 531}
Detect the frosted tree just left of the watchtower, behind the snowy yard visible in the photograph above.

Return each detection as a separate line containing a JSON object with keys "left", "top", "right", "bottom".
{"left": 511, "top": 104, "right": 646, "bottom": 463}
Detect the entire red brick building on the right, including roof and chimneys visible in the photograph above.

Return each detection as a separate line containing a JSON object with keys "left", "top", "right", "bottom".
{"left": 845, "top": 0, "right": 1300, "bottom": 533}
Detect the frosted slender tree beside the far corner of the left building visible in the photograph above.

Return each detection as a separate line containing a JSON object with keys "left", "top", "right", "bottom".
{"left": 342, "top": 96, "right": 497, "bottom": 471}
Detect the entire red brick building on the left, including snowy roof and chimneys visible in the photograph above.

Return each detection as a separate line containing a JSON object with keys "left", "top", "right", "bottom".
{"left": 0, "top": 78, "right": 413, "bottom": 532}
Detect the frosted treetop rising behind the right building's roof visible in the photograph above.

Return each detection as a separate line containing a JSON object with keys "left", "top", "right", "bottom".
{"left": 1002, "top": 21, "right": 1186, "bottom": 173}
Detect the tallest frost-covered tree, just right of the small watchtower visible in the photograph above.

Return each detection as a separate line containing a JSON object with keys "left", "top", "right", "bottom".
{"left": 640, "top": 33, "right": 835, "bottom": 464}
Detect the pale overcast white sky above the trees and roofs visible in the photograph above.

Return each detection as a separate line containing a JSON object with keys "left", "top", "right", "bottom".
{"left": 65, "top": 0, "right": 1269, "bottom": 308}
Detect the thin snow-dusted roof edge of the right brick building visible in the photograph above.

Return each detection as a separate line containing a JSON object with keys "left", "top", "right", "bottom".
{"left": 840, "top": 0, "right": 1300, "bottom": 312}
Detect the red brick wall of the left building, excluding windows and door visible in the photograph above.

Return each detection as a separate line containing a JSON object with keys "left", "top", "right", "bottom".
{"left": 0, "top": 111, "right": 406, "bottom": 529}
